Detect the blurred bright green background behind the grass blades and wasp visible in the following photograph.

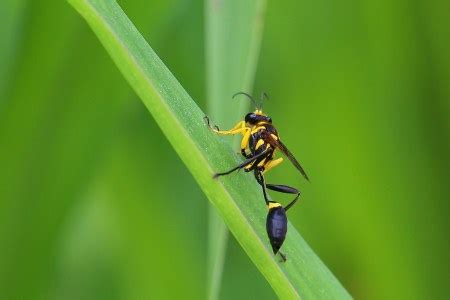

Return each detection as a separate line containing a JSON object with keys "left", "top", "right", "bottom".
{"left": 0, "top": 0, "right": 450, "bottom": 299}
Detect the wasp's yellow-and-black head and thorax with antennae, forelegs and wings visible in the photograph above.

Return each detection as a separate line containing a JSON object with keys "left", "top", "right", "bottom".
{"left": 205, "top": 92, "right": 309, "bottom": 181}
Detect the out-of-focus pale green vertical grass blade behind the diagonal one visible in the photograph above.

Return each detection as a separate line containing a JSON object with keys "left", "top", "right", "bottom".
{"left": 205, "top": 0, "right": 266, "bottom": 299}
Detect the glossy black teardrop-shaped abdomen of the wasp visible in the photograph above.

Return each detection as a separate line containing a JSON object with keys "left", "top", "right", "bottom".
{"left": 266, "top": 206, "right": 287, "bottom": 254}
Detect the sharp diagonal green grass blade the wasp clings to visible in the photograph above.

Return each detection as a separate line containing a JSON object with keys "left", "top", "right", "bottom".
{"left": 70, "top": 0, "right": 350, "bottom": 299}
